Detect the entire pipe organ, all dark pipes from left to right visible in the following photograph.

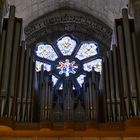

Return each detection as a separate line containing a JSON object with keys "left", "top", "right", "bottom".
{"left": 0, "top": 6, "right": 140, "bottom": 130}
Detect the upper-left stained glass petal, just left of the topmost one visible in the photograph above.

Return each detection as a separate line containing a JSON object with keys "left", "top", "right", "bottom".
{"left": 36, "top": 44, "right": 58, "bottom": 61}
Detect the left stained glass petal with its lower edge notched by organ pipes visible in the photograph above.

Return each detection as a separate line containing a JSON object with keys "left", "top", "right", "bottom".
{"left": 35, "top": 61, "right": 51, "bottom": 72}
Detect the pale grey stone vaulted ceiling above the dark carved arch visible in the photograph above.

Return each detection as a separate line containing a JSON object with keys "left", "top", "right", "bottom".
{"left": 8, "top": 0, "right": 128, "bottom": 28}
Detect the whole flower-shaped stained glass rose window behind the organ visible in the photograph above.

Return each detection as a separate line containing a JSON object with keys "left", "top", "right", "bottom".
{"left": 35, "top": 35, "right": 102, "bottom": 89}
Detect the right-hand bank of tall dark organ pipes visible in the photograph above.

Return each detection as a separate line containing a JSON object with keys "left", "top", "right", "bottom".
{"left": 100, "top": 9, "right": 140, "bottom": 122}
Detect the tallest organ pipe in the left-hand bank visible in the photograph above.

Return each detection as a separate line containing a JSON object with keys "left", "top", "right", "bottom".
{"left": 1, "top": 6, "right": 15, "bottom": 100}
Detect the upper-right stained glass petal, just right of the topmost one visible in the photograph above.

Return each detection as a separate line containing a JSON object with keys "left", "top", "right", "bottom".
{"left": 76, "top": 43, "right": 97, "bottom": 60}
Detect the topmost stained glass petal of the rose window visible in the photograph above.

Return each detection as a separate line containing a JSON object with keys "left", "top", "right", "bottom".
{"left": 57, "top": 36, "right": 76, "bottom": 55}
